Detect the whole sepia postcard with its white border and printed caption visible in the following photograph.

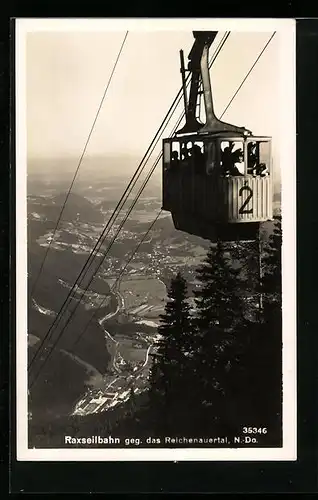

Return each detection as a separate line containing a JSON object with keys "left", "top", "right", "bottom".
{"left": 15, "top": 18, "right": 297, "bottom": 461}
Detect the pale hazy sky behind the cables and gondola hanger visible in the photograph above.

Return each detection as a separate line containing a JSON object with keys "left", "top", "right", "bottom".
{"left": 26, "top": 25, "right": 286, "bottom": 182}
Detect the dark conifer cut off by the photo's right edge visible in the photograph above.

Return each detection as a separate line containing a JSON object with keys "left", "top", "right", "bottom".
{"left": 231, "top": 216, "right": 282, "bottom": 438}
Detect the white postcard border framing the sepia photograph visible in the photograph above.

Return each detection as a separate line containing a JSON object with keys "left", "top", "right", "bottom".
{"left": 16, "top": 18, "right": 297, "bottom": 461}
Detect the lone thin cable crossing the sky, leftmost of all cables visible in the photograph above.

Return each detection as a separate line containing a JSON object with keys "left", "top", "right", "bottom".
{"left": 31, "top": 31, "right": 128, "bottom": 296}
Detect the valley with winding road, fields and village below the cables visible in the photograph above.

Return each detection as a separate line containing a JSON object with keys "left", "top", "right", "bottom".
{"left": 28, "top": 174, "right": 208, "bottom": 440}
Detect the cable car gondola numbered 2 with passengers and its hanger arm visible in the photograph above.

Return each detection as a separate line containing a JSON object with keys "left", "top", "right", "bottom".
{"left": 162, "top": 31, "right": 273, "bottom": 242}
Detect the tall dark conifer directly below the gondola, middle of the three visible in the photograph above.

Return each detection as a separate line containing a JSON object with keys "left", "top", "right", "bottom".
{"left": 194, "top": 242, "right": 244, "bottom": 432}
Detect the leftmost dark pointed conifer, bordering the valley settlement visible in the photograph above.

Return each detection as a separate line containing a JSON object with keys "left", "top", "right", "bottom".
{"left": 149, "top": 273, "right": 193, "bottom": 432}
